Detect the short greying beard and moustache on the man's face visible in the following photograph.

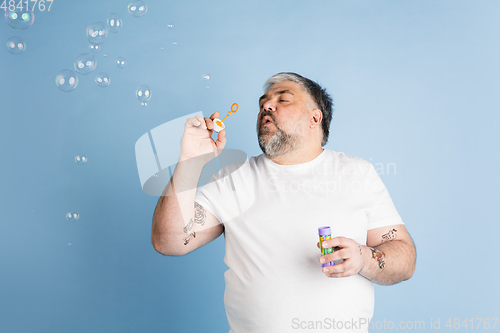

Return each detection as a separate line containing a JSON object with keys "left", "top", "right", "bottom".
{"left": 257, "top": 113, "right": 303, "bottom": 158}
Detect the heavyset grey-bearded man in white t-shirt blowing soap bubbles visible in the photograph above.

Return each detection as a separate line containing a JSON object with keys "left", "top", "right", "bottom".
{"left": 152, "top": 73, "right": 415, "bottom": 333}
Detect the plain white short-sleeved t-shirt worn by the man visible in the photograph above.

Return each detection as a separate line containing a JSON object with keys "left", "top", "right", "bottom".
{"left": 195, "top": 149, "right": 403, "bottom": 333}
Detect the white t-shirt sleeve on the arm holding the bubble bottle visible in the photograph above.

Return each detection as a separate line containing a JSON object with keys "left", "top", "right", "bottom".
{"left": 367, "top": 163, "right": 404, "bottom": 230}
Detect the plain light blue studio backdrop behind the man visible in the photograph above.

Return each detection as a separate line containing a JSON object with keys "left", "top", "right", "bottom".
{"left": 0, "top": 0, "right": 500, "bottom": 333}
